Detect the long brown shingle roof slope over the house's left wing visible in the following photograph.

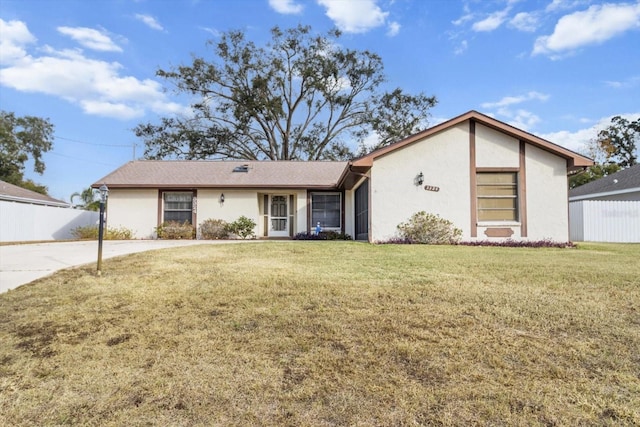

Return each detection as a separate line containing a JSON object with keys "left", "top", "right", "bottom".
{"left": 93, "top": 160, "right": 348, "bottom": 188}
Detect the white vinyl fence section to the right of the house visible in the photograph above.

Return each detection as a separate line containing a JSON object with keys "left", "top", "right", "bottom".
{"left": 569, "top": 200, "right": 640, "bottom": 243}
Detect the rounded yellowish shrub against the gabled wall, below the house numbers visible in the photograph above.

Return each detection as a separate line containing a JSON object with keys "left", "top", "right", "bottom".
{"left": 398, "top": 211, "right": 462, "bottom": 245}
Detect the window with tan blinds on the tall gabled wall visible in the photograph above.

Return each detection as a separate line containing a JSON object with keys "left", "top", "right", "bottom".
{"left": 477, "top": 172, "right": 518, "bottom": 221}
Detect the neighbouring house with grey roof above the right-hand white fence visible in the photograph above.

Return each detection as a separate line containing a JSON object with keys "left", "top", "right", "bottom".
{"left": 569, "top": 165, "right": 640, "bottom": 202}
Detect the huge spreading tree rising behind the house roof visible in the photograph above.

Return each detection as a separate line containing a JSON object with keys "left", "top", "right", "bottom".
{"left": 134, "top": 26, "right": 436, "bottom": 160}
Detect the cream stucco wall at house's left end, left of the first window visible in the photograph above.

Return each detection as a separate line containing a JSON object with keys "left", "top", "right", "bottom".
{"left": 107, "top": 188, "right": 158, "bottom": 239}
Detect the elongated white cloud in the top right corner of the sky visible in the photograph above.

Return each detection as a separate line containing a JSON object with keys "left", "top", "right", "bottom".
{"left": 532, "top": 3, "right": 640, "bottom": 56}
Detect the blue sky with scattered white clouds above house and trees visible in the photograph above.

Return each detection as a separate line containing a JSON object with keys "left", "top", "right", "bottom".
{"left": 0, "top": 0, "right": 640, "bottom": 201}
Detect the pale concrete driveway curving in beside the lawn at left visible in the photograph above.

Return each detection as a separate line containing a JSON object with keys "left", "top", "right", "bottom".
{"left": 0, "top": 240, "right": 246, "bottom": 293}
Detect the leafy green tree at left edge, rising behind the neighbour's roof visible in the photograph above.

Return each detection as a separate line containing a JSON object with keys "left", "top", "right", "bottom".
{"left": 0, "top": 111, "right": 53, "bottom": 194}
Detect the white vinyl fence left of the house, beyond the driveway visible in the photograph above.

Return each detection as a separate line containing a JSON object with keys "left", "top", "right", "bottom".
{"left": 0, "top": 200, "right": 100, "bottom": 242}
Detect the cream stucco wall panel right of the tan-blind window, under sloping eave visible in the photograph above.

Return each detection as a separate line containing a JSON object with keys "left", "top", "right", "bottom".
{"left": 525, "top": 145, "right": 569, "bottom": 242}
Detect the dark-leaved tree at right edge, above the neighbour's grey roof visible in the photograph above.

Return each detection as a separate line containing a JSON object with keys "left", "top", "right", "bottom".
{"left": 595, "top": 116, "right": 640, "bottom": 169}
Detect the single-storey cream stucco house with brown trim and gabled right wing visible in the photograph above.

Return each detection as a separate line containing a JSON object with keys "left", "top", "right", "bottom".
{"left": 93, "top": 111, "right": 593, "bottom": 242}
